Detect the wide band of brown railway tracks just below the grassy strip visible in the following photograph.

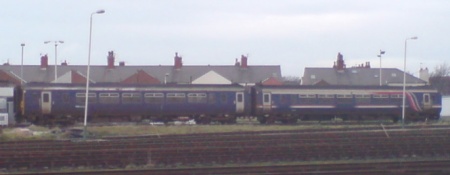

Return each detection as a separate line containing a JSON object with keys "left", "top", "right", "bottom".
{"left": 0, "top": 128, "right": 450, "bottom": 171}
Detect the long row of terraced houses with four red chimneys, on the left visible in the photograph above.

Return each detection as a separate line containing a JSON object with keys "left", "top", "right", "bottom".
{"left": 0, "top": 51, "right": 282, "bottom": 85}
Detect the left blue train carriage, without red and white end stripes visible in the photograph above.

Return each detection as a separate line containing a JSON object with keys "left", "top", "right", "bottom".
{"left": 23, "top": 83, "right": 250, "bottom": 124}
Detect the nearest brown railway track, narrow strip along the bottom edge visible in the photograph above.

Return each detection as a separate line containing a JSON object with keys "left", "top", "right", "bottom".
{"left": 7, "top": 160, "right": 450, "bottom": 175}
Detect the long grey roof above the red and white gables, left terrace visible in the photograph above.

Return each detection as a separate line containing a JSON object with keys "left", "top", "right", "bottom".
{"left": 0, "top": 65, "right": 281, "bottom": 84}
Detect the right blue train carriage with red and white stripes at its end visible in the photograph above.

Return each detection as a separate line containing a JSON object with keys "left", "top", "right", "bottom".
{"left": 254, "top": 85, "right": 441, "bottom": 123}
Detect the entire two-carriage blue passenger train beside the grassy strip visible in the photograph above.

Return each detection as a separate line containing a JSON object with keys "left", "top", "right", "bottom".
{"left": 6, "top": 83, "right": 442, "bottom": 125}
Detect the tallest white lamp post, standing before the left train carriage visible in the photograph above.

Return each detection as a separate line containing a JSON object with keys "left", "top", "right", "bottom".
{"left": 83, "top": 10, "right": 105, "bottom": 139}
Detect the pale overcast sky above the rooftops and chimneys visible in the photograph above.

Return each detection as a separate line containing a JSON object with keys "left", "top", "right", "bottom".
{"left": 0, "top": 0, "right": 450, "bottom": 77}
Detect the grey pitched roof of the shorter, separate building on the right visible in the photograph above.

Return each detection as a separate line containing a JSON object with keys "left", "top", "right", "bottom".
{"left": 302, "top": 67, "right": 427, "bottom": 86}
